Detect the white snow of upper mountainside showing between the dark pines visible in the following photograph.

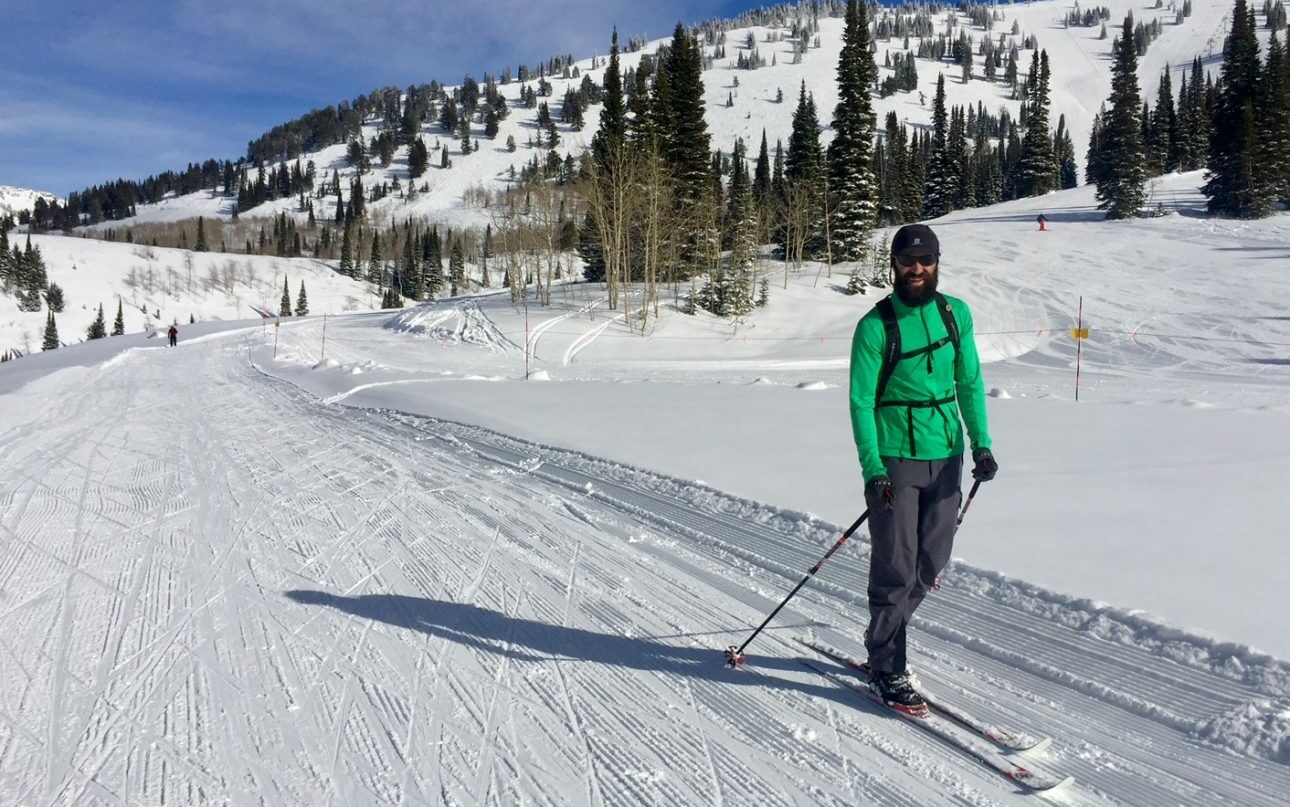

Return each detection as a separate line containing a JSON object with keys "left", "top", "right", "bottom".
{"left": 83, "top": 0, "right": 1231, "bottom": 235}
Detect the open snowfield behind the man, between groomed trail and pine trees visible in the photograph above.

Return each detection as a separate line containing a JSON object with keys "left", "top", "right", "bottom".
{"left": 251, "top": 173, "right": 1290, "bottom": 657}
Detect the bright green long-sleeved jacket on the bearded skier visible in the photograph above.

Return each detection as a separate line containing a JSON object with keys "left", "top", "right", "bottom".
{"left": 851, "top": 294, "right": 991, "bottom": 482}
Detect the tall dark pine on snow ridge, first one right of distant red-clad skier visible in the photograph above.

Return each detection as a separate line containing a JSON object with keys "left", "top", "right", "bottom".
{"left": 1097, "top": 14, "right": 1147, "bottom": 219}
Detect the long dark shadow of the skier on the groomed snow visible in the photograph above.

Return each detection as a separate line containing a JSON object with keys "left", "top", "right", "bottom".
{"left": 286, "top": 589, "right": 866, "bottom": 706}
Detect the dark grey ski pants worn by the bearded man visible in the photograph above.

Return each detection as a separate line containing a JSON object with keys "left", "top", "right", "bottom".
{"left": 864, "top": 455, "right": 964, "bottom": 673}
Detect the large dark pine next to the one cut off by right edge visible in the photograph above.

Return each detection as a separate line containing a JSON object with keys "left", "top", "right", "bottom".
{"left": 1204, "top": 0, "right": 1264, "bottom": 218}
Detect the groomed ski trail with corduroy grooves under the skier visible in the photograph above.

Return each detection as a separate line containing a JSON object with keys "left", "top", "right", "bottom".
{"left": 0, "top": 334, "right": 1290, "bottom": 806}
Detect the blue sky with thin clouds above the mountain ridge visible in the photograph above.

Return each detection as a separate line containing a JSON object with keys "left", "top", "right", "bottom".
{"left": 0, "top": 0, "right": 760, "bottom": 196}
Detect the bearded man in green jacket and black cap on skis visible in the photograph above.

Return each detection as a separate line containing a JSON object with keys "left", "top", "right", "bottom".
{"left": 851, "top": 224, "right": 998, "bottom": 714}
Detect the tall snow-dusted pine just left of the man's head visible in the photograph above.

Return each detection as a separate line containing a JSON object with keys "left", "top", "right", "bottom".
{"left": 828, "top": 0, "right": 877, "bottom": 260}
